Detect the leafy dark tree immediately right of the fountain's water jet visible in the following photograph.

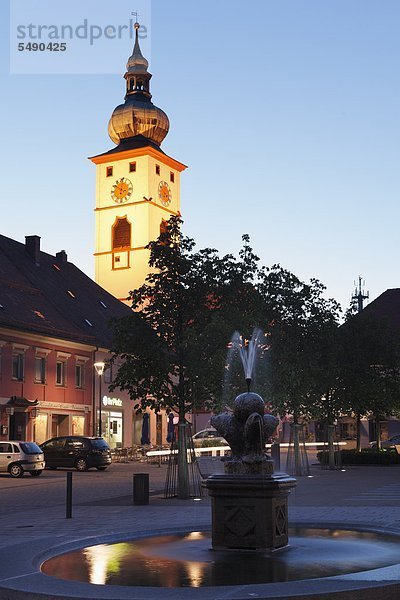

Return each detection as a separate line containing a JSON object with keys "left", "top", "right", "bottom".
{"left": 264, "top": 270, "right": 339, "bottom": 475}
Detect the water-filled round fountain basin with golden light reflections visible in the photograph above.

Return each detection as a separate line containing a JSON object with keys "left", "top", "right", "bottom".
{"left": 41, "top": 527, "right": 400, "bottom": 598}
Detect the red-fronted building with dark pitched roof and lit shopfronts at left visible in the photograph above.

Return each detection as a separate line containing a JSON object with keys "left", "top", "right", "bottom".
{"left": 0, "top": 236, "right": 167, "bottom": 448}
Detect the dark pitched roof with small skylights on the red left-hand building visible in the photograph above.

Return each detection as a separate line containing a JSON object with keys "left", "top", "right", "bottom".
{"left": 0, "top": 235, "right": 132, "bottom": 348}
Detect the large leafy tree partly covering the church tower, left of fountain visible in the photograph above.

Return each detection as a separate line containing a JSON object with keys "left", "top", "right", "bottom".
{"left": 112, "top": 217, "right": 263, "bottom": 498}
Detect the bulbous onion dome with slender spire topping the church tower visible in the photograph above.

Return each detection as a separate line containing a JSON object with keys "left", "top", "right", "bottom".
{"left": 108, "top": 23, "right": 169, "bottom": 146}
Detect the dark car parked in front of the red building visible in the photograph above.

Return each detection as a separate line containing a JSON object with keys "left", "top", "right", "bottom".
{"left": 40, "top": 435, "right": 111, "bottom": 471}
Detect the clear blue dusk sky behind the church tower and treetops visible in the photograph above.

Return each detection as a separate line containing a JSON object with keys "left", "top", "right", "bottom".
{"left": 0, "top": 0, "right": 400, "bottom": 316}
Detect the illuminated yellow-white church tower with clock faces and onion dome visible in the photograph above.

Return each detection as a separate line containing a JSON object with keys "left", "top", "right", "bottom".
{"left": 90, "top": 23, "right": 186, "bottom": 301}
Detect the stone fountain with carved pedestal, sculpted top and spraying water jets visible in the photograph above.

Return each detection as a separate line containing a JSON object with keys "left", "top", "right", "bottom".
{"left": 206, "top": 330, "right": 296, "bottom": 551}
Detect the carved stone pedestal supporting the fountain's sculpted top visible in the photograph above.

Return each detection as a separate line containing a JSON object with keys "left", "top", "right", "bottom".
{"left": 205, "top": 474, "right": 296, "bottom": 550}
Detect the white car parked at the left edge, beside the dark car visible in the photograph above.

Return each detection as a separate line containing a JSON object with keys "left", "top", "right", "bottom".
{"left": 0, "top": 440, "right": 45, "bottom": 477}
